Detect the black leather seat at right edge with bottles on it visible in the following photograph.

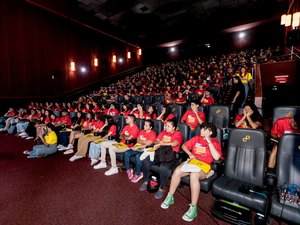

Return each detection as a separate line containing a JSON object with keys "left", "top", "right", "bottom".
{"left": 270, "top": 134, "right": 300, "bottom": 224}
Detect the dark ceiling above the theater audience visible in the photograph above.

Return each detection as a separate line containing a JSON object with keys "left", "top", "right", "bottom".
{"left": 60, "top": 0, "right": 288, "bottom": 46}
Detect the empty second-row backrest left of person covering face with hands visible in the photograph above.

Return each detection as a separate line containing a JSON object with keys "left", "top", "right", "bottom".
{"left": 207, "top": 105, "right": 230, "bottom": 128}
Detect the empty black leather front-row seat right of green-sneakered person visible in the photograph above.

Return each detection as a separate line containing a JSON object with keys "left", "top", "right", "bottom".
{"left": 212, "top": 129, "right": 267, "bottom": 213}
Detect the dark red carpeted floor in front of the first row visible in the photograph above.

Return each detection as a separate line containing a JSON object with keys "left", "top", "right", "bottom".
{"left": 0, "top": 134, "right": 286, "bottom": 225}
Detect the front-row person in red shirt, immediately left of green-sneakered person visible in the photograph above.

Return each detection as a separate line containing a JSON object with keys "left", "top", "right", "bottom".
{"left": 140, "top": 119, "right": 182, "bottom": 199}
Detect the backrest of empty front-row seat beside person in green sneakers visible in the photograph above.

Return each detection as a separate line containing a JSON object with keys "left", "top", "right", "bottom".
{"left": 225, "top": 128, "right": 267, "bottom": 187}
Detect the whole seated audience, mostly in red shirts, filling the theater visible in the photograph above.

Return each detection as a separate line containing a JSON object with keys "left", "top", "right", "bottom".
{"left": 0, "top": 46, "right": 300, "bottom": 221}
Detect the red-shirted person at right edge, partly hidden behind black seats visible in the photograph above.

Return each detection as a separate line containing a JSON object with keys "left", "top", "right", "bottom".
{"left": 268, "top": 113, "right": 300, "bottom": 170}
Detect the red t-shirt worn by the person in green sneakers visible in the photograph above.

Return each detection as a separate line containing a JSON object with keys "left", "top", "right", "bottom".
{"left": 184, "top": 136, "right": 222, "bottom": 164}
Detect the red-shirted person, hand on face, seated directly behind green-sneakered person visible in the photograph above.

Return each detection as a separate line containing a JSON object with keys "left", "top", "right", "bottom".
{"left": 181, "top": 101, "right": 205, "bottom": 139}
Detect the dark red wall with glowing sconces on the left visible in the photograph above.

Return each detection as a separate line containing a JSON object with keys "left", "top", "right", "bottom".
{"left": 0, "top": 0, "right": 142, "bottom": 98}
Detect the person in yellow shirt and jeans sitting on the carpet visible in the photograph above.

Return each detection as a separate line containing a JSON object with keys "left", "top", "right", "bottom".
{"left": 23, "top": 123, "right": 57, "bottom": 158}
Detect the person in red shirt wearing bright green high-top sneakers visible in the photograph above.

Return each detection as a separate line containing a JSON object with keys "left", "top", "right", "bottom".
{"left": 161, "top": 123, "right": 222, "bottom": 222}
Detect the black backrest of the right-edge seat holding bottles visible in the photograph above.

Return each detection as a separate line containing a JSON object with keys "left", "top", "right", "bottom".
{"left": 276, "top": 134, "right": 300, "bottom": 186}
